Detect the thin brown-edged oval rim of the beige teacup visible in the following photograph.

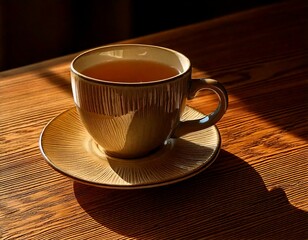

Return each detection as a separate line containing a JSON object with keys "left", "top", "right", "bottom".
{"left": 70, "top": 43, "right": 191, "bottom": 86}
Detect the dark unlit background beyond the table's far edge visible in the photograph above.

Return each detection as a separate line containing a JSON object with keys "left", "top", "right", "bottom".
{"left": 0, "top": 0, "right": 282, "bottom": 71}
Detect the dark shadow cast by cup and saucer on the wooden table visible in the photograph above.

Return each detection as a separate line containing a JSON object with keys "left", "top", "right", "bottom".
{"left": 74, "top": 150, "right": 308, "bottom": 240}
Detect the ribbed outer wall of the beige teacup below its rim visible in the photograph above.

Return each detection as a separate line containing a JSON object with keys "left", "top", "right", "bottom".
{"left": 72, "top": 72, "right": 190, "bottom": 158}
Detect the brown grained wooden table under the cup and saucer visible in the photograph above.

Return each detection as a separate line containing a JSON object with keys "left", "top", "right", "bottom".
{"left": 0, "top": 1, "right": 308, "bottom": 240}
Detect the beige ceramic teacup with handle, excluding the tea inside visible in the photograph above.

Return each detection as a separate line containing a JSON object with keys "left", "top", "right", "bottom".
{"left": 71, "top": 44, "right": 228, "bottom": 158}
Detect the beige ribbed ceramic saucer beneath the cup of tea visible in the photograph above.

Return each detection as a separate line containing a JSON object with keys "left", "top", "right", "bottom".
{"left": 39, "top": 107, "right": 221, "bottom": 189}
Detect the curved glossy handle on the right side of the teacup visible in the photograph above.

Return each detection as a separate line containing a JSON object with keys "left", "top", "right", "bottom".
{"left": 172, "top": 78, "right": 228, "bottom": 137}
